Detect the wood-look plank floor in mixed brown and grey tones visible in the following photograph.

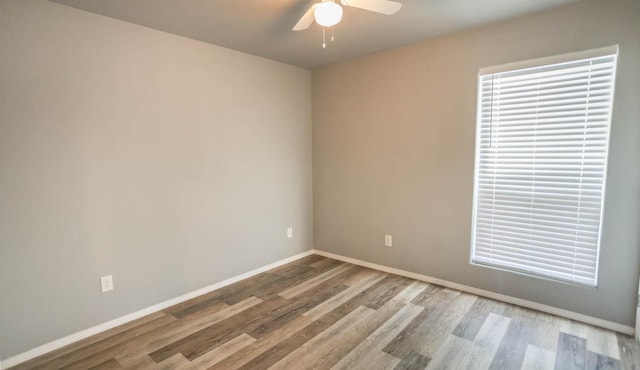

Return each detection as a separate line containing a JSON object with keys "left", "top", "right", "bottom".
{"left": 13, "top": 255, "right": 640, "bottom": 370}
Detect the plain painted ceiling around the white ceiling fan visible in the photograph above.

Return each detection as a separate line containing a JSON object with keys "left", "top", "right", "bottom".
{"left": 51, "top": 0, "right": 580, "bottom": 68}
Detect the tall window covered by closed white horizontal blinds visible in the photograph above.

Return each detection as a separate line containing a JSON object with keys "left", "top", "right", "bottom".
{"left": 471, "top": 46, "right": 618, "bottom": 286}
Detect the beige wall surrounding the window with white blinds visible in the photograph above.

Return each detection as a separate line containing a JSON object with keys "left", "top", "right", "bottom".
{"left": 312, "top": 0, "right": 640, "bottom": 326}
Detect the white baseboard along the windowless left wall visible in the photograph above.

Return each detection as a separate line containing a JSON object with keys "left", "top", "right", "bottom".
{"left": 0, "top": 250, "right": 314, "bottom": 370}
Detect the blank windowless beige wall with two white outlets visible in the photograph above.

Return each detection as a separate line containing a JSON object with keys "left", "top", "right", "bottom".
{"left": 0, "top": 0, "right": 312, "bottom": 359}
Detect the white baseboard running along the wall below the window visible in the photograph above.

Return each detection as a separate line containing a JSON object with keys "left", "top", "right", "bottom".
{"left": 313, "top": 249, "right": 635, "bottom": 335}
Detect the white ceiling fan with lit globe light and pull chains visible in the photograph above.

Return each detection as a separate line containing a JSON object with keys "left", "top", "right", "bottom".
{"left": 293, "top": 0, "right": 402, "bottom": 48}
